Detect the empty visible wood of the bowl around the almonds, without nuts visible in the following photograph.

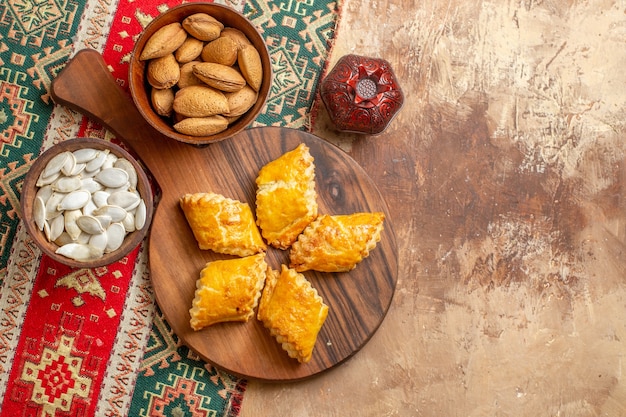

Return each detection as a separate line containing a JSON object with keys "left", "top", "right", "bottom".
{"left": 129, "top": 3, "right": 272, "bottom": 145}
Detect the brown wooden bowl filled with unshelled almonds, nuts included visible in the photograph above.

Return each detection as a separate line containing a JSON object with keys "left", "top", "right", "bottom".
{"left": 129, "top": 3, "right": 272, "bottom": 145}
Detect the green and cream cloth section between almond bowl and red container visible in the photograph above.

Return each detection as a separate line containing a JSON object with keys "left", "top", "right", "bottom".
{"left": 244, "top": 0, "right": 338, "bottom": 130}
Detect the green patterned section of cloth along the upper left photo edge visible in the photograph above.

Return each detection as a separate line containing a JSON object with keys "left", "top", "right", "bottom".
{"left": 0, "top": 0, "right": 84, "bottom": 280}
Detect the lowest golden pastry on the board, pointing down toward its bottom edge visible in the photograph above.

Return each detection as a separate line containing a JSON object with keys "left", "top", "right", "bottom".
{"left": 257, "top": 265, "right": 328, "bottom": 363}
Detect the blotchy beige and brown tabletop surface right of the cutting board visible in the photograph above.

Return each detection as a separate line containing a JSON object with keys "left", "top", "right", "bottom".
{"left": 241, "top": 0, "right": 626, "bottom": 417}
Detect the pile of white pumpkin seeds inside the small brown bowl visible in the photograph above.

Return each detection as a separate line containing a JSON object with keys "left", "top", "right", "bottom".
{"left": 33, "top": 148, "right": 146, "bottom": 261}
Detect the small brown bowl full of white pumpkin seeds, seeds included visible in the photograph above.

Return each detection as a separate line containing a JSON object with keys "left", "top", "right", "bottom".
{"left": 20, "top": 138, "right": 153, "bottom": 268}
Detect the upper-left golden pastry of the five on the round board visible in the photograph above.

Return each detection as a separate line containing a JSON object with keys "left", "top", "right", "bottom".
{"left": 180, "top": 193, "right": 267, "bottom": 256}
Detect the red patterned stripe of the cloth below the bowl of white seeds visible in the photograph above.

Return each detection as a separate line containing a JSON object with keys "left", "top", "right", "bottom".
{"left": 2, "top": 248, "right": 139, "bottom": 416}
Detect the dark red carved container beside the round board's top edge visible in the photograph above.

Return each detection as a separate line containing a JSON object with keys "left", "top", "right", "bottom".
{"left": 320, "top": 55, "right": 404, "bottom": 135}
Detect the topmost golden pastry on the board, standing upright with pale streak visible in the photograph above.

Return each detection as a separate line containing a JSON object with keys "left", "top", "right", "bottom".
{"left": 256, "top": 143, "right": 317, "bottom": 249}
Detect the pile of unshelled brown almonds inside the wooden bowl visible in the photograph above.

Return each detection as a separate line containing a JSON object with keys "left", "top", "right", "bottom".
{"left": 139, "top": 13, "right": 263, "bottom": 136}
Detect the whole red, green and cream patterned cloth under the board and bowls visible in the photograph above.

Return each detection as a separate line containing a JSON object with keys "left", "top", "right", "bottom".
{"left": 0, "top": 0, "right": 338, "bottom": 417}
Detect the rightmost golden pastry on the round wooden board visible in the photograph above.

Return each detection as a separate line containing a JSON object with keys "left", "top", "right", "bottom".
{"left": 289, "top": 212, "right": 385, "bottom": 272}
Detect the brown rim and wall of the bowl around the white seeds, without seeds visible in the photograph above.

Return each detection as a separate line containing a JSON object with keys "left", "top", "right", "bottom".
{"left": 20, "top": 138, "right": 154, "bottom": 268}
